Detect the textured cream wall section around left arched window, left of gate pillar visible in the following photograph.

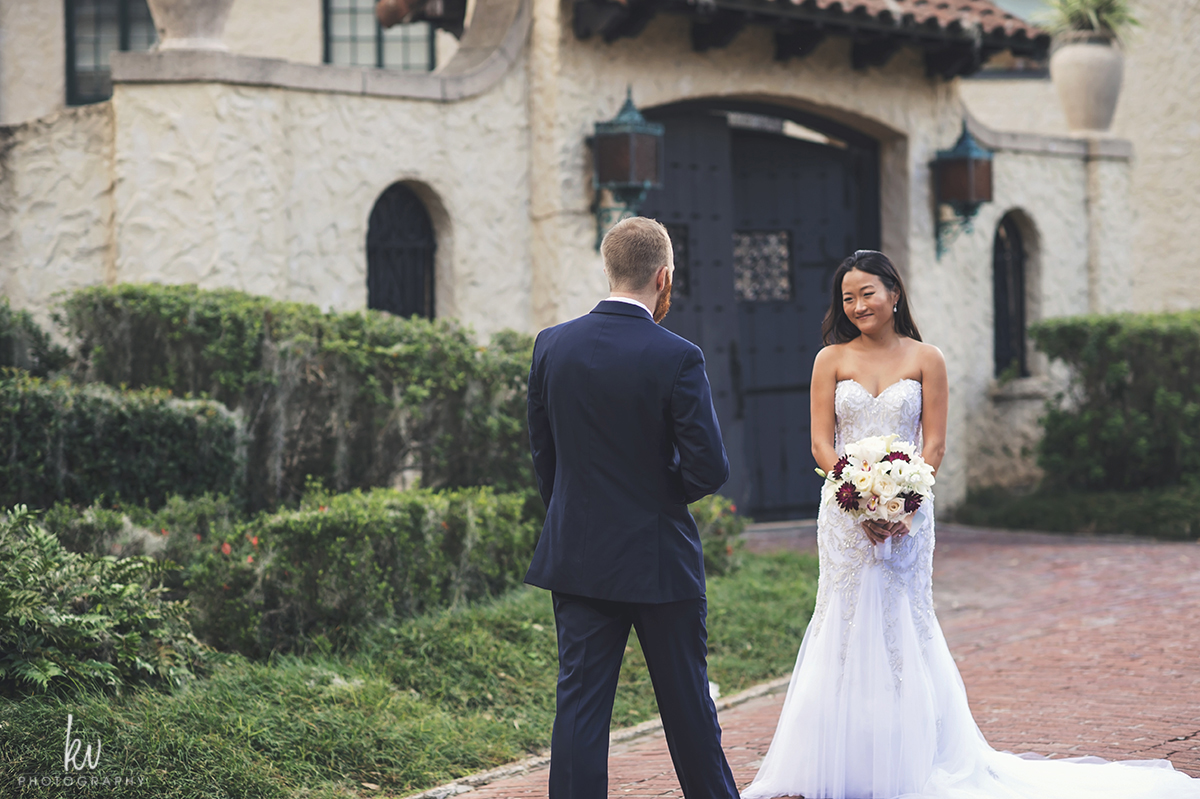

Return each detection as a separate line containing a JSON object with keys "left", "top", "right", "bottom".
{"left": 113, "top": 62, "right": 530, "bottom": 334}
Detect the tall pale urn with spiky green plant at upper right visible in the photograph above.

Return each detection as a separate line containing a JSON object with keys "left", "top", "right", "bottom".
{"left": 1040, "top": 0, "right": 1138, "bottom": 132}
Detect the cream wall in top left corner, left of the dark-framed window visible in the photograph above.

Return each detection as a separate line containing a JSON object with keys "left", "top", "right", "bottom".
{"left": 0, "top": 0, "right": 66, "bottom": 125}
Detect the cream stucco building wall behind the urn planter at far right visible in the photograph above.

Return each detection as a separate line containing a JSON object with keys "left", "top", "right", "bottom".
{"left": 961, "top": 0, "right": 1200, "bottom": 311}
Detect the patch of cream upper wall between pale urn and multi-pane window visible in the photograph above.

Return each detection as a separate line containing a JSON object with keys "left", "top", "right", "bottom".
{"left": 224, "top": 0, "right": 324, "bottom": 64}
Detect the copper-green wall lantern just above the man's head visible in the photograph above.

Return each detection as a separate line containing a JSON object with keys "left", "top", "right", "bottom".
{"left": 588, "top": 88, "right": 664, "bottom": 250}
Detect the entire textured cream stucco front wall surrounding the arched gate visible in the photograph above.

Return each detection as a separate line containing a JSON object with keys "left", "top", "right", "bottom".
{"left": 0, "top": 0, "right": 1123, "bottom": 506}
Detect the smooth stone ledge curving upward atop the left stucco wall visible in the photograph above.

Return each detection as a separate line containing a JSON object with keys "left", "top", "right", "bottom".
{"left": 112, "top": 0, "right": 533, "bottom": 102}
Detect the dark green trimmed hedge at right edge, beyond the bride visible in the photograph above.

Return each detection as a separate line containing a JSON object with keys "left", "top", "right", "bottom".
{"left": 1031, "top": 312, "right": 1200, "bottom": 491}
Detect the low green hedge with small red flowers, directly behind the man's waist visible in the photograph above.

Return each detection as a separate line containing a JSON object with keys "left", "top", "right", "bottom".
{"left": 41, "top": 486, "right": 746, "bottom": 656}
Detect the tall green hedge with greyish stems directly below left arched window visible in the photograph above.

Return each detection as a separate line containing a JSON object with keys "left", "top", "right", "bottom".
{"left": 62, "top": 286, "right": 533, "bottom": 509}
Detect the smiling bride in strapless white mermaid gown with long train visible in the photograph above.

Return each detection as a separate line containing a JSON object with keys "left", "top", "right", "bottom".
{"left": 742, "top": 250, "right": 1200, "bottom": 799}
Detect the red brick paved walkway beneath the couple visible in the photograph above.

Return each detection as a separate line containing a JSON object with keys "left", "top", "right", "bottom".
{"left": 453, "top": 524, "right": 1200, "bottom": 799}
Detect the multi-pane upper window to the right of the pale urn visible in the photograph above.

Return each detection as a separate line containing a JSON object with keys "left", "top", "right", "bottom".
{"left": 324, "top": 0, "right": 437, "bottom": 72}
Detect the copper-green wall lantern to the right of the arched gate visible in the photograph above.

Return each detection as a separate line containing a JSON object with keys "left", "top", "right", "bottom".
{"left": 932, "top": 120, "right": 992, "bottom": 258}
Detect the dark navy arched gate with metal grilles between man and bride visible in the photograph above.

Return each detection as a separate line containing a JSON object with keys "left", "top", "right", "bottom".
{"left": 642, "top": 103, "right": 880, "bottom": 519}
